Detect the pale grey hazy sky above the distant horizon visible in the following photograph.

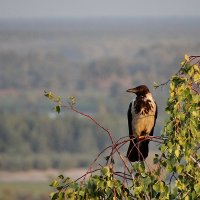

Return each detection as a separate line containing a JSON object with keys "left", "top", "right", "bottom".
{"left": 0, "top": 0, "right": 200, "bottom": 19}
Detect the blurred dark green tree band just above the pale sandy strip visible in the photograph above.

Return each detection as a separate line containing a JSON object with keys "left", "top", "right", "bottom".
{"left": 0, "top": 113, "right": 126, "bottom": 170}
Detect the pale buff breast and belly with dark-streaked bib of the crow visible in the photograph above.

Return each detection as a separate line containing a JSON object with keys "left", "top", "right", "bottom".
{"left": 131, "top": 93, "right": 156, "bottom": 137}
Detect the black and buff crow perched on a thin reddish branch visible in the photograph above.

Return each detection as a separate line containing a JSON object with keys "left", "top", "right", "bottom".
{"left": 126, "top": 85, "right": 157, "bottom": 162}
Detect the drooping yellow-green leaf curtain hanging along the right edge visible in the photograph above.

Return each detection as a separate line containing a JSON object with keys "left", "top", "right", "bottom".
{"left": 160, "top": 55, "right": 200, "bottom": 199}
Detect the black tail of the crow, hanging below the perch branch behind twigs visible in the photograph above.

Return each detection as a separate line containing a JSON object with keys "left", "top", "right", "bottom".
{"left": 127, "top": 139, "right": 149, "bottom": 162}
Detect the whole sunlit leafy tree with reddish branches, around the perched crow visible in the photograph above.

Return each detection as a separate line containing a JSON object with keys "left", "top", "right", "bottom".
{"left": 45, "top": 55, "right": 200, "bottom": 200}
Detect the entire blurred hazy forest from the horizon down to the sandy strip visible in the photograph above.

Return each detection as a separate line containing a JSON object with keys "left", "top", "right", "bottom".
{"left": 0, "top": 19, "right": 200, "bottom": 171}
